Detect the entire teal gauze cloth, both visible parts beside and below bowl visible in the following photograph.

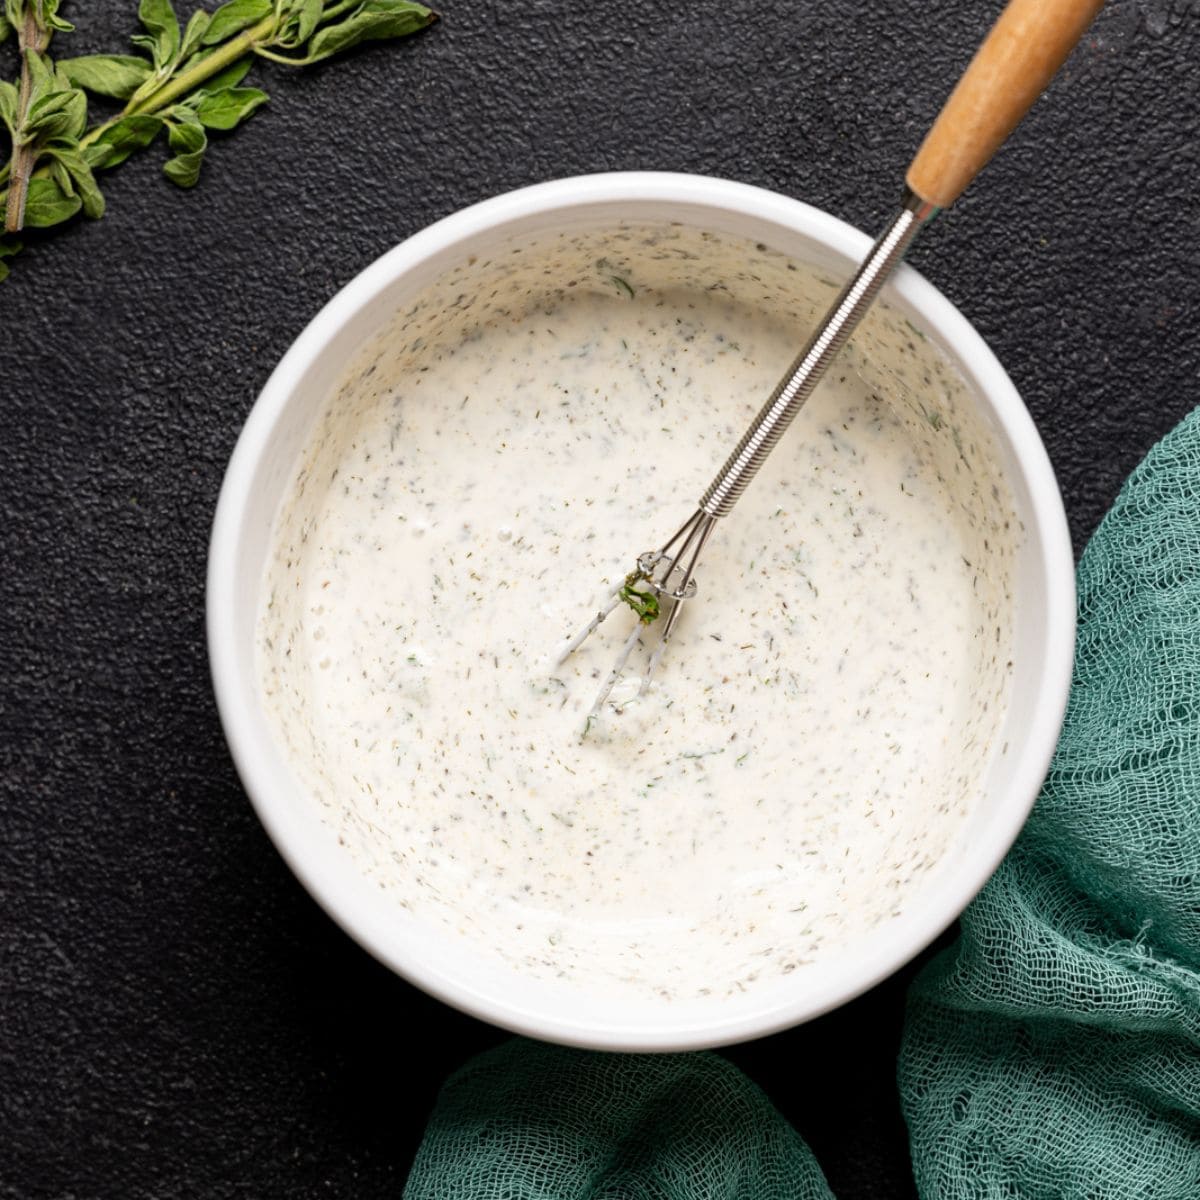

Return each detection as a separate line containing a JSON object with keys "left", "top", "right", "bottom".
{"left": 404, "top": 410, "right": 1200, "bottom": 1200}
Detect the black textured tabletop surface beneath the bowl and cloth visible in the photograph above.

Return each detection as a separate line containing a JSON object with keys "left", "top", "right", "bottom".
{"left": 0, "top": 0, "right": 1200, "bottom": 1200}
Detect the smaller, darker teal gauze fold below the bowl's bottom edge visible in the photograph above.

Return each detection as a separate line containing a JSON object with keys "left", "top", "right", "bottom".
{"left": 404, "top": 1039, "right": 833, "bottom": 1200}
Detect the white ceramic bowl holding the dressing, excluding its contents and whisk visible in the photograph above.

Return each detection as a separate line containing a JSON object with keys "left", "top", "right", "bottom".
{"left": 208, "top": 173, "right": 1075, "bottom": 1050}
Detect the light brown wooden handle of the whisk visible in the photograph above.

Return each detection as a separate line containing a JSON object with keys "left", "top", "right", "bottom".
{"left": 906, "top": 0, "right": 1104, "bottom": 209}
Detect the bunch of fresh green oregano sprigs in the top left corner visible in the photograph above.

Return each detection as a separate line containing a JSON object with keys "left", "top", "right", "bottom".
{"left": 0, "top": 0, "right": 437, "bottom": 280}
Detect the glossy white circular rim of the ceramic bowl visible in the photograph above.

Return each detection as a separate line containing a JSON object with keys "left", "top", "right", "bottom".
{"left": 206, "top": 172, "right": 1075, "bottom": 1051}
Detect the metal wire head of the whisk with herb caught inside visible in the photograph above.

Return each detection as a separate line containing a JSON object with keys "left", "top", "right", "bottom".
{"left": 558, "top": 509, "right": 716, "bottom": 724}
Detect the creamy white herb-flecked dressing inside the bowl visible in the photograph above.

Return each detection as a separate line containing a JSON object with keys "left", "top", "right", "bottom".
{"left": 258, "top": 227, "right": 1015, "bottom": 998}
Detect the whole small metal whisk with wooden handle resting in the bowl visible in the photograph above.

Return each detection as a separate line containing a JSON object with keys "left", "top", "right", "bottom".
{"left": 559, "top": 0, "right": 1104, "bottom": 725}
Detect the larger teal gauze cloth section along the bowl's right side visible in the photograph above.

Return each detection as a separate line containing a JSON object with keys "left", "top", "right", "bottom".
{"left": 900, "top": 413, "right": 1200, "bottom": 1200}
